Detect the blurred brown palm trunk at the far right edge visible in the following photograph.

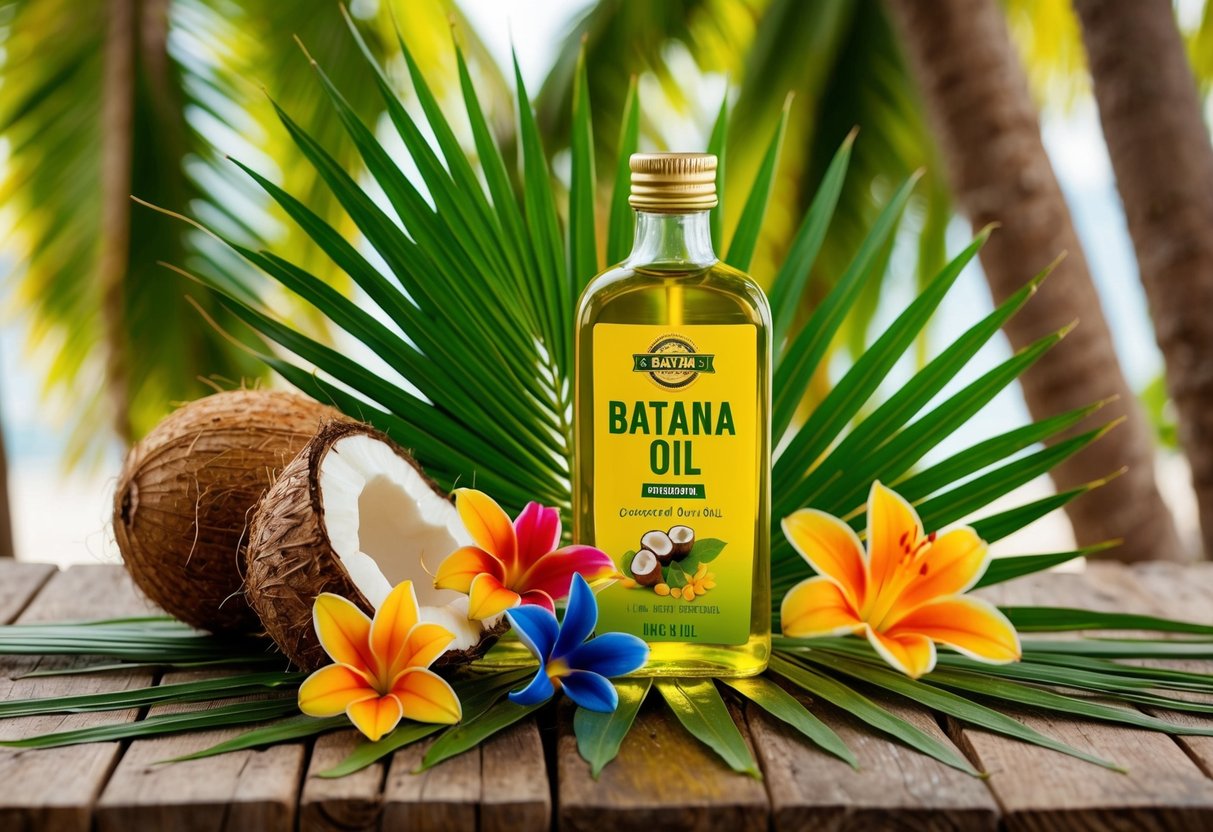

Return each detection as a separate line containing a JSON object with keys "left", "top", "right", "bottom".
{"left": 1075, "top": 0, "right": 1213, "bottom": 557}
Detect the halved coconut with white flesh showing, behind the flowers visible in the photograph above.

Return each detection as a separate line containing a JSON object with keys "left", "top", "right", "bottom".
{"left": 245, "top": 424, "right": 497, "bottom": 669}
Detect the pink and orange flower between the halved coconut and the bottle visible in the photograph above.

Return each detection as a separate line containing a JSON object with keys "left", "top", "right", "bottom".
{"left": 434, "top": 489, "right": 615, "bottom": 620}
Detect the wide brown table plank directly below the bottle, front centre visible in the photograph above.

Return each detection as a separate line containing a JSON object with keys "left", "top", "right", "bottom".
{"left": 557, "top": 691, "right": 770, "bottom": 832}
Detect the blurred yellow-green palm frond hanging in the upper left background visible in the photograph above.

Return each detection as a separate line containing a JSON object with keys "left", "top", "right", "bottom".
{"left": 0, "top": 0, "right": 505, "bottom": 462}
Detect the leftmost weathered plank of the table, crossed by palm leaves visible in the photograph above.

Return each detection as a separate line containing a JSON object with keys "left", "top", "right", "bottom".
{"left": 0, "top": 565, "right": 154, "bottom": 832}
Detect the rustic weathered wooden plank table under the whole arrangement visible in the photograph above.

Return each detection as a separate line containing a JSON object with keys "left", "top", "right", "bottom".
{"left": 0, "top": 563, "right": 1213, "bottom": 832}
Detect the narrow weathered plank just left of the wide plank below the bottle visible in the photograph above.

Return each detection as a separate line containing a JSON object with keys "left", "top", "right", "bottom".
{"left": 480, "top": 719, "right": 552, "bottom": 832}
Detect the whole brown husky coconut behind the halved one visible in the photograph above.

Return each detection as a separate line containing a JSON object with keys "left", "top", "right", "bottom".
{"left": 114, "top": 391, "right": 344, "bottom": 633}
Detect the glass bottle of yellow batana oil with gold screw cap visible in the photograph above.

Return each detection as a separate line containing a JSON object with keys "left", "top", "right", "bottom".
{"left": 574, "top": 154, "right": 770, "bottom": 677}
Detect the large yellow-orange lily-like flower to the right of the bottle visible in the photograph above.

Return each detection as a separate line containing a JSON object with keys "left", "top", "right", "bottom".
{"left": 781, "top": 483, "right": 1021, "bottom": 678}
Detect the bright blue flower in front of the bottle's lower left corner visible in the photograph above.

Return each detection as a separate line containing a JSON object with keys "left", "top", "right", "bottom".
{"left": 506, "top": 575, "right": 649, "bottom": 712}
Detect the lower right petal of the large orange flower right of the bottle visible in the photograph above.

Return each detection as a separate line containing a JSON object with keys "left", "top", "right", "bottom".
{"left": 885, "top": 595, "right": 1023, "bottom": 665}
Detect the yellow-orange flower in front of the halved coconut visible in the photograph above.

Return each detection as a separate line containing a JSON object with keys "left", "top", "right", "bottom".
{"left": 300, "top": 581, "right": 462, "bottom": 742}
